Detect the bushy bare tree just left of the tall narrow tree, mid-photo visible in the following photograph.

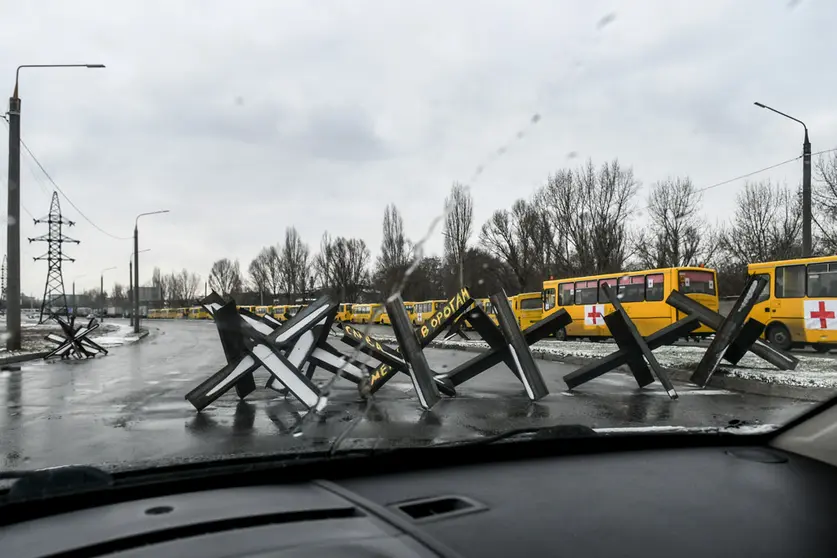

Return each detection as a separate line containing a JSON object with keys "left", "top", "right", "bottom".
{"left": 314, "top": 233, "right": 370, "bottom": 301}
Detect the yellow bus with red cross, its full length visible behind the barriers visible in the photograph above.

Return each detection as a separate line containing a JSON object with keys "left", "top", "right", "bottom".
{"left": 543, "top": 267, "right": 718, "bottom": 340}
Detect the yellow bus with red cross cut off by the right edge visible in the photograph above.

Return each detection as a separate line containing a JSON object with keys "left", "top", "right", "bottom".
{"left": 747, "top": 256, "right": 837, "bottom": 353}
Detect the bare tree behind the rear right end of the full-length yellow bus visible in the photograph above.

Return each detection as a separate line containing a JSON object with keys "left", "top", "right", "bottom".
{"left": 636, "top": 177, "right": 719, "bottom": 268}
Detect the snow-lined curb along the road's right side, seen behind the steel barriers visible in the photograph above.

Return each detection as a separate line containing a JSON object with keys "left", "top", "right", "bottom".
{"left": 370, "top": 336, "right": 837, "bottom": 402}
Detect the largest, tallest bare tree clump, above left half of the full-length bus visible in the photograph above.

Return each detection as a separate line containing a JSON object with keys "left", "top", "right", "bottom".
{"left": 542, "top": 160, "right": 638, "bottom": 274}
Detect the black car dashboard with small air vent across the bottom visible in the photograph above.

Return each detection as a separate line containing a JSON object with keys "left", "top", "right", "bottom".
{"left": 0, "top": 444, "right": 837, "bottom": 558}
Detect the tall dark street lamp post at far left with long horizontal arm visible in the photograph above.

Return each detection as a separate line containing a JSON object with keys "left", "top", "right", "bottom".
{"left": 6, "top": 64, "right": 105, "bottom": 351}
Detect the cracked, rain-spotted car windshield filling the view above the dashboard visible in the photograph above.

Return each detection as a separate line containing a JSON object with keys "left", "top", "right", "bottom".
{"left": 0, "top": 0, "right": 837, "bottom": 484}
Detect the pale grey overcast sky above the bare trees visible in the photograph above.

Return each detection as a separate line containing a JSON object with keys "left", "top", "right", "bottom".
{"left": 0, "top": 0, "right": 837, "bottom": 296}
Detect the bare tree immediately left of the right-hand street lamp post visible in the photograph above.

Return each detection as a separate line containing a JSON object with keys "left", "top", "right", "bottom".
{"left": 723, "top": 180, "right": 802, "bottom": 265}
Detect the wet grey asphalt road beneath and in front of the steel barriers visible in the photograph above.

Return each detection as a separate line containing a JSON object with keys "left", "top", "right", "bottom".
{"left": 0, "top": 321, "right": 811, "bottom": 469}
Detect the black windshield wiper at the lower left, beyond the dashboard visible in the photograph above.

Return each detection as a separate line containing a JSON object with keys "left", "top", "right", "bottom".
{"left": 0, "top": 465, "right": 114, "bottom": 503}
